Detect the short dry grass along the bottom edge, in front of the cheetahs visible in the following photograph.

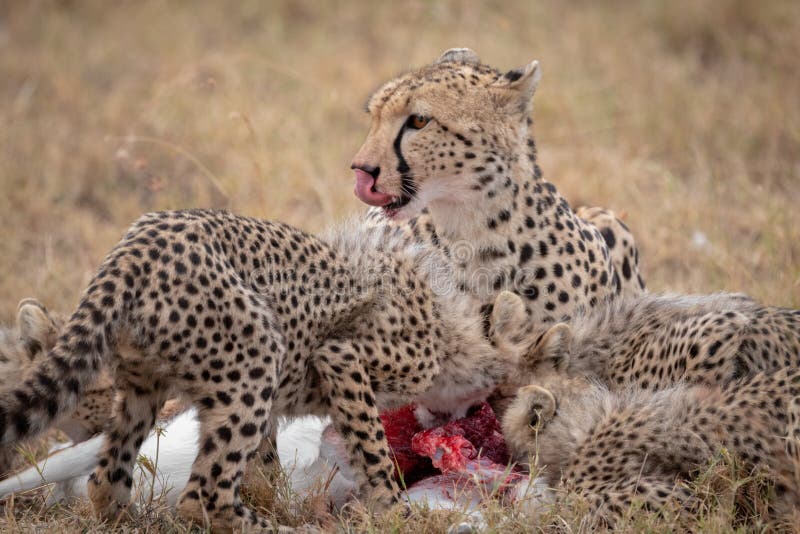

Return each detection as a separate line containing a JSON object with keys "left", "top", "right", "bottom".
{"left": 0, "top": 457, "right": 800, "bottom": 534}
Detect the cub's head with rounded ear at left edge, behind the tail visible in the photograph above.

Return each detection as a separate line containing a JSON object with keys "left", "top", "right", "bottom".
{"left": 0, "top": 298, "right": 62, "bottom": 365}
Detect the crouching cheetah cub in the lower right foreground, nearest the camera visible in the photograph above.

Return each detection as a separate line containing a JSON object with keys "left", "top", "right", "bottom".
{"left": 502, "top": 368, "right": 800, "bottom": 527}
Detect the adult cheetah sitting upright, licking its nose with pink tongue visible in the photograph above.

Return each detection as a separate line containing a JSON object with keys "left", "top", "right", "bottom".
{"left": 351, "top": 48, "right": 644, "bottom": 338}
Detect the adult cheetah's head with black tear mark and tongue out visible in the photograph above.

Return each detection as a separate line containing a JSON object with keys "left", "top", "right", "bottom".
{"left": 352, "top": 49, "right": 540, "bottom": 218}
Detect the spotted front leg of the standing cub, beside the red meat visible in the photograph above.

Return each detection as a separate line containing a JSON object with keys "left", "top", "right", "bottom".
{"left": 314, "top": 341, "right": 400, "bottom": 509}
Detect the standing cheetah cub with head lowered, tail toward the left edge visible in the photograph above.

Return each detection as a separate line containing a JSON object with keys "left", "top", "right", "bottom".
{"left": 0, "top": 210, "right": 524, "bottom": 530}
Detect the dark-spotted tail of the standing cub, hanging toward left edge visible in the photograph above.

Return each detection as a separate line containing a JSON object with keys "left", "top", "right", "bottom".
{"left": 0, "top": 281, "right": 122, "bottom": 445}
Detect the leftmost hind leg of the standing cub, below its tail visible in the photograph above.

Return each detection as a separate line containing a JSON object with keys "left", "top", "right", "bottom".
{"left": 88, "top": 385, "right": 164, "bottom": 519}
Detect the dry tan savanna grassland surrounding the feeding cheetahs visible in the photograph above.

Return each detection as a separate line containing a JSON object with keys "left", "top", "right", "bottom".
{"left": 0, "top": 0, "right": 800, "bottom": 531}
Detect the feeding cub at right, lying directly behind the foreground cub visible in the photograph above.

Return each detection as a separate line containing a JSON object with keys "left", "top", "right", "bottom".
{"left": 518, "top": 293, "right": 800, "bottom": 389}
